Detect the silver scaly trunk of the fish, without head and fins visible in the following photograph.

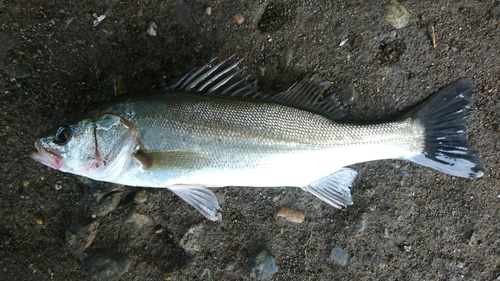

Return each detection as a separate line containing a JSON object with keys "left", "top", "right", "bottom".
{"left": 97, "top": 93, "right": 423, "bottom": 187}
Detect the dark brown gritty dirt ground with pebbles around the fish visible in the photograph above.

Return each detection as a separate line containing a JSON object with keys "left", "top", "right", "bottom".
{"left": 0, "top": 0, "right": 500, "bottom": 280}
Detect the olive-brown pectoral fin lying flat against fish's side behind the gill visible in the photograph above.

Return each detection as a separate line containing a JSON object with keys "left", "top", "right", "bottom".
{"left": 134, "top": 150, "right": 209, "bottom": 171}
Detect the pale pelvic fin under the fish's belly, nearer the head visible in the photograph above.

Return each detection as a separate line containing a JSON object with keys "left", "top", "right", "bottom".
{"left": 168, "top": 185, "right": 222, "bottom": 221}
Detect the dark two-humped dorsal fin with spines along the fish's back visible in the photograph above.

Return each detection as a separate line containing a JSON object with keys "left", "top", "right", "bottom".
{"left": 167, "top": 56, "right": 346, "bottom": 120}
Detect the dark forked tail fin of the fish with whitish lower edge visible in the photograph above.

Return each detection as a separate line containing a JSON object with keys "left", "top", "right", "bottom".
{"left": 406, "top": 78, "right": 483, "bottom": 178}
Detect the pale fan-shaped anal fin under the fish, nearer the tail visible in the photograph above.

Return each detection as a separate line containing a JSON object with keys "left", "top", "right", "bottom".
{"left": 302, "top": 168, "right": 358, "bottom": 209}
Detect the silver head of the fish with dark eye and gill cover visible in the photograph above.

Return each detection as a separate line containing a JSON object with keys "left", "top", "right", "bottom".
{"left": 30, "top": 114, "right": 139, "bottom": 181}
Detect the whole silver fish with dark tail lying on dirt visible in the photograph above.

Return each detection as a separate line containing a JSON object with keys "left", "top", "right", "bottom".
{"left": 30, "top": 57, "right": 484, "bottom": 221}
